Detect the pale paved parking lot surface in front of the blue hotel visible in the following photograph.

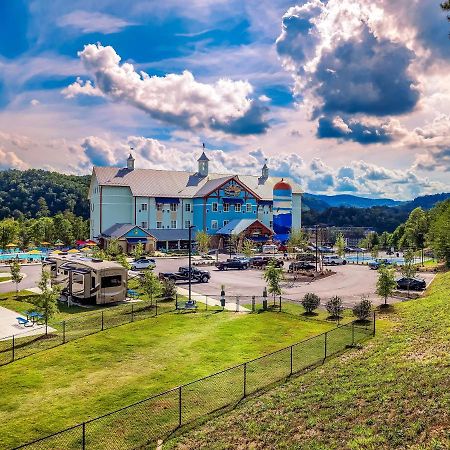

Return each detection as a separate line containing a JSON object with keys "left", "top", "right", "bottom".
{"left": 150, "top": 256, "right": 433, "bottom": 306}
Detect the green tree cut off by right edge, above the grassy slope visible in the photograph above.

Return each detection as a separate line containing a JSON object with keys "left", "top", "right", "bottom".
{"left": 427, "top": 199, "right": 450, "bottom": 268}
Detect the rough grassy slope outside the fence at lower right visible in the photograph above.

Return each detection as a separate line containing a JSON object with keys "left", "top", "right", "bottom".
{"left": 169, "top": 272, "right": 450, "bottom": 450}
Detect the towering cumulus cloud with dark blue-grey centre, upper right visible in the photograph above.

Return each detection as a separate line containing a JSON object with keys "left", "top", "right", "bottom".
{"left": 277, "top": 0, "right": 420, "bottom": 144}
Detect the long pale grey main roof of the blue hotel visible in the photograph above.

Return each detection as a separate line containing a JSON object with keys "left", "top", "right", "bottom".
{"left": 94, "top": 167, "right": 302, "bottom": 200}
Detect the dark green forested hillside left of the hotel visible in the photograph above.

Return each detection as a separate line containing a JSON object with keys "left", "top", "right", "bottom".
{"left": 0, "top": 169, "right": 91, "bottom": 219}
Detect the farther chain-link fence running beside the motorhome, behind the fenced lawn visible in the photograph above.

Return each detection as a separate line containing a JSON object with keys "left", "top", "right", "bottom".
{"left": 0, "top": 298, "right": 176, "bottom": 366}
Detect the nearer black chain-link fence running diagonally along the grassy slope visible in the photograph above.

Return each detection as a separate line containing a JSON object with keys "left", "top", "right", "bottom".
{"left": 14, "top": 314, "right": 375, "bottom": 450}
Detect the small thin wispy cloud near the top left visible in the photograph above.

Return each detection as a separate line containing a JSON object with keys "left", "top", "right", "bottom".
{"left": 57, "top": 10, "right": 133, "bottom": 34}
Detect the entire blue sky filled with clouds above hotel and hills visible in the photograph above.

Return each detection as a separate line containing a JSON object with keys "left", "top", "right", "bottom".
{"left": 0, "top": 0, "right": 450, "bottom": 200}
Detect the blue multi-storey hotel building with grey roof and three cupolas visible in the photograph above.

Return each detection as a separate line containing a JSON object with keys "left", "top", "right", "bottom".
{"left": 89, "top": 152, "right": 301, "bottom": 249}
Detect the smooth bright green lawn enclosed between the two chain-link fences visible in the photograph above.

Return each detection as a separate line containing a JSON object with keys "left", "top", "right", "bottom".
{"left": 0, "top": 306, "right": 334, "bottom": 448}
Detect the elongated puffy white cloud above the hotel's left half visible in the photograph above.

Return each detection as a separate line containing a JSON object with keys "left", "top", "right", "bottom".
{"left": 63, "top": 44, "right": 268, "bottom": 135}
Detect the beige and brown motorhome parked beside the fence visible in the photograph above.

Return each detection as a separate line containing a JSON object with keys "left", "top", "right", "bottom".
{"left": 43, "top": 256, "right": 128, "bottom": 305}
